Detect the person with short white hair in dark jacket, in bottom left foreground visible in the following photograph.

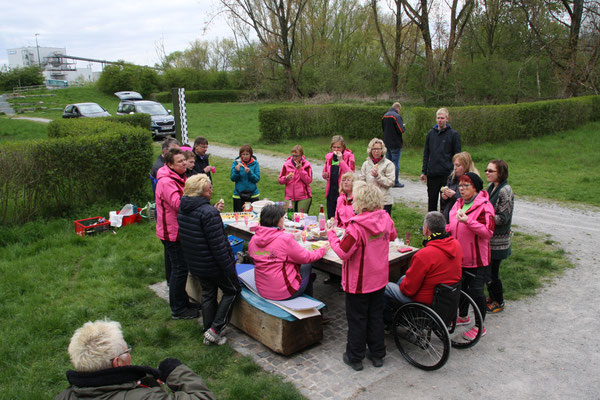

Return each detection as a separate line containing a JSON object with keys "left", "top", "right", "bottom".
{"left": 56, "top": 319, "right": 215, "bottom": 400}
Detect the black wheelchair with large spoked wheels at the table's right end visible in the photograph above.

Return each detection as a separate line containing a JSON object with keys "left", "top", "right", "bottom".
{"left": 392, "top": 281, "right": 483, "bottom": 371}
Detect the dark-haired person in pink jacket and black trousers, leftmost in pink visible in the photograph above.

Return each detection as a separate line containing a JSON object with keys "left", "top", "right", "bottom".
{"left": 155, "top": 148, "right": 199, "bottom": 319}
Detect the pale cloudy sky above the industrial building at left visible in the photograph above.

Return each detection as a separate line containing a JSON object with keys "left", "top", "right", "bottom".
{"left": 0, "top": 0, "right": 233, "bottom": 70}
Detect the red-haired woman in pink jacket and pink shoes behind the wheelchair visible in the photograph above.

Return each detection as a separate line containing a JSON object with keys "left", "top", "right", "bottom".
{"left": 446, "top": 172, "right": 495, "bottom": 340}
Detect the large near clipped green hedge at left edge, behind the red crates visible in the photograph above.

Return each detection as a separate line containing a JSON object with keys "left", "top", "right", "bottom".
{"left": 0, "top": 120, "right": 152, "bottom": 225}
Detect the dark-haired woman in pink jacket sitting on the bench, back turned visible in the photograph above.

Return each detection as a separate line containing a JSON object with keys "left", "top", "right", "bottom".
{"left": 248, "top": 204, "right": 329, "bottom": 300}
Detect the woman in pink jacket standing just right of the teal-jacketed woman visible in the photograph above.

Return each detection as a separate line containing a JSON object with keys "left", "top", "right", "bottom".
{"left": 279, "top": 144, "right": 312, "bottom": 214}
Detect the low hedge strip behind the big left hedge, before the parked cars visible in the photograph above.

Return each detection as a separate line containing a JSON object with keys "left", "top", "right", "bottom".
{"left": 48, "top": 114, "right": 152, "bottom": 138}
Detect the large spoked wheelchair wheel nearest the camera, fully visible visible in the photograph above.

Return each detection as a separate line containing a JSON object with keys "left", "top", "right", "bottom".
{"left": 392, "top": 303, "right": 450, "bottom": 371}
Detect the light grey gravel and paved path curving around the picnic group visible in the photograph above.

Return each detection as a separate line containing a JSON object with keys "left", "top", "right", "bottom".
{"left": 156, "top": 144, "right": 600, "bottom": 399}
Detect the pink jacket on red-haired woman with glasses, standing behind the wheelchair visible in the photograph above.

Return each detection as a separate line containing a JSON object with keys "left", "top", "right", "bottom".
{"left": 446, "top": 190, "right": 495, "bottom": 268}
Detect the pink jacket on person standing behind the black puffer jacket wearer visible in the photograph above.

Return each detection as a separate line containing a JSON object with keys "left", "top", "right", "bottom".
{"left": 155, "top": 164, "right": 187, "bottom": 242}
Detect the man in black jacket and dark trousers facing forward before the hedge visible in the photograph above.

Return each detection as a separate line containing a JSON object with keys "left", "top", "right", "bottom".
{"left": 421, "top": 108, "right": 461, "bottom": 211}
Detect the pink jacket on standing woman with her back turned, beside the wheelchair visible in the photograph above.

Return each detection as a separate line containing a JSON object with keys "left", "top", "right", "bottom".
{"left": 327, "top": 210, "right": 397, "bottom": 294}
